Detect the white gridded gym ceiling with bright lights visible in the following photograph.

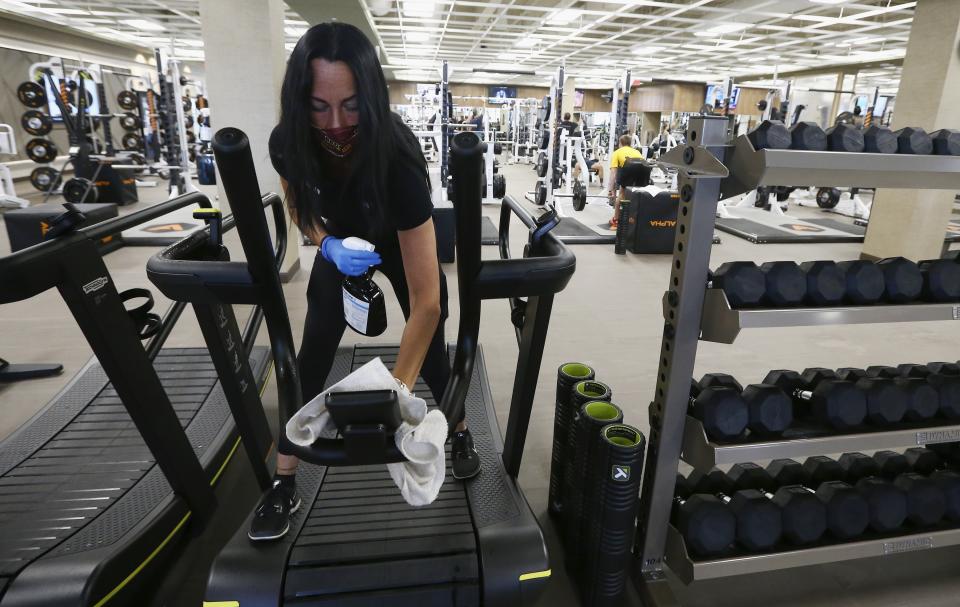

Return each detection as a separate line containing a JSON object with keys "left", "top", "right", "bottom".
{"left": 0, "top": 0, "right": 916, "bottom": 91}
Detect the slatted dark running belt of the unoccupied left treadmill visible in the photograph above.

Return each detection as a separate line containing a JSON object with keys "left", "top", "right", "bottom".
{"left": 0, "top": 348, "right": 268, "bottom": 602}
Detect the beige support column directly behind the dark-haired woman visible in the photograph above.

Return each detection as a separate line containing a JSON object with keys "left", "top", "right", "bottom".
{"left": 200, "top": 0, "right": 300, "bottom": 281}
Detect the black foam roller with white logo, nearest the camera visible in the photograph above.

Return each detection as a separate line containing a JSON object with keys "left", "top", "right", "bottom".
{"left": 580, "top": 424, "right": 646, "bottom": 607}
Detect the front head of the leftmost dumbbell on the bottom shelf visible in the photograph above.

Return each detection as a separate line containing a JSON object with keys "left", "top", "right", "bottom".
{"left": 677, "top": 493, "right": 737, "bottom": 556}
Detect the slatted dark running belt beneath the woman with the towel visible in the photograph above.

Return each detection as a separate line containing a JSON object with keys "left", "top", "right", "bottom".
{"left": 283, "top": 346, "right": 480, "bottom": 607}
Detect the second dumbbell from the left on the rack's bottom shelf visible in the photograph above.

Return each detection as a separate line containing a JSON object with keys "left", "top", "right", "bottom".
{"left": 678, "top": 468, "right": 782, "bottom": 552}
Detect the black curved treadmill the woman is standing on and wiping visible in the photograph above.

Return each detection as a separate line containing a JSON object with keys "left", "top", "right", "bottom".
{"left": 148, "top": 128, "right": 576, "bottom": 607}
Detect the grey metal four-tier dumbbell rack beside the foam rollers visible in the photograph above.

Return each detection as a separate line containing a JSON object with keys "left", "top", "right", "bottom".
{"left": 633, "top": 116, "right": 960, "bottom": 607}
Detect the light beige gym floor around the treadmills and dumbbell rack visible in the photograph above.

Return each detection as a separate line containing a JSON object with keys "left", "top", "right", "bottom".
{"left": 0, "top": 163, "right": 960, "bottom": 607}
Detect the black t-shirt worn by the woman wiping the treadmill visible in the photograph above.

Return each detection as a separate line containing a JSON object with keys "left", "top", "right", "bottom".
{"left": 269, "top": 127, "right": 433, "bottom": 248}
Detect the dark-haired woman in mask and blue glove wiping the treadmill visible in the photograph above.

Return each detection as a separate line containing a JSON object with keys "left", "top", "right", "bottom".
{"left": 249, "top": 23, "right": 480, "bottom": 540}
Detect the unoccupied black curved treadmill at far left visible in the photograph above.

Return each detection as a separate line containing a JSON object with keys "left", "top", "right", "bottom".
{"left": 0, "top": 193, "right": 286, "bottom": 607}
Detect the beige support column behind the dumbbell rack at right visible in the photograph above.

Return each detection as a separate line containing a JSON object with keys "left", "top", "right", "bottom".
{"left": 861, "top": 0, "right": 960, "bottom": 260}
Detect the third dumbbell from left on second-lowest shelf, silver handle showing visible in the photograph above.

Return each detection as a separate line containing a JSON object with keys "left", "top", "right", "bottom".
{"left": 763, "top": 368, "right": 867, "bottom": 430}
